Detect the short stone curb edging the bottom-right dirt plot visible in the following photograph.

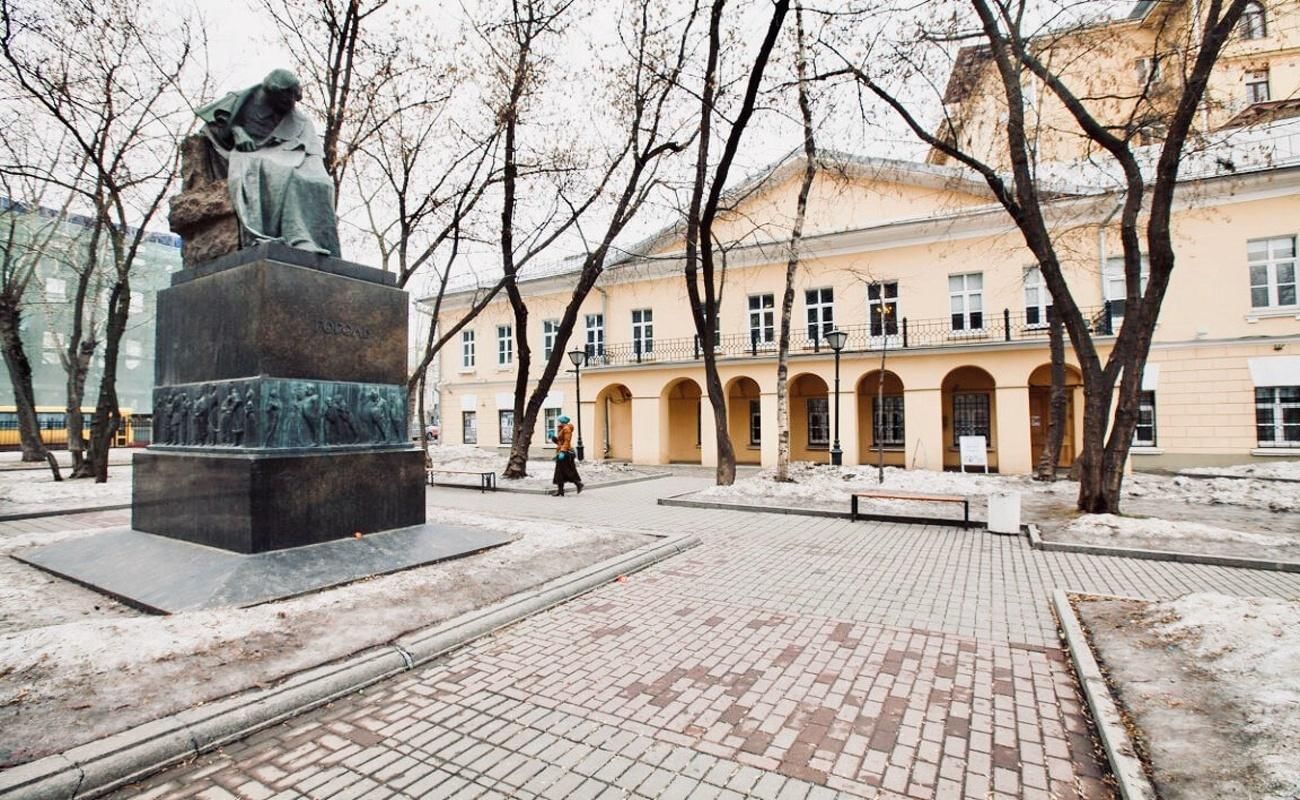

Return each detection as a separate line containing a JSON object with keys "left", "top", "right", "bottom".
{"left": 1052, "top": 589, "right": 1158, "bottom": 800}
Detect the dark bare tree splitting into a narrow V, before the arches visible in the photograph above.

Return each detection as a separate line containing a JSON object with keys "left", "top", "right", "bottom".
{"left": 685, "top": 0, "right": 790, "bottom": 485}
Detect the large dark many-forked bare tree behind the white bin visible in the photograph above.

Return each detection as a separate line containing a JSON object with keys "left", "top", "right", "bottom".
{"left": 822, "top": 0, "right": 1245, "bottom": 514}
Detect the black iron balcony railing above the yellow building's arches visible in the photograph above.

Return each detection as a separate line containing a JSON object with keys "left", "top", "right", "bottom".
{"left": 585, "top": 302, "right": 1121, "bottom": 367}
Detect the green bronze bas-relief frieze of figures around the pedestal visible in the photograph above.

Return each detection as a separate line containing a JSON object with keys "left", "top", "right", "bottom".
{"left": 153, "top": 377, "right": 406, "bottom": 450}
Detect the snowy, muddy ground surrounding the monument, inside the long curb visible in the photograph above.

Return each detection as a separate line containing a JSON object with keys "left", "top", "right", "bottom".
{"left": 0, "top": 505, "right": 654, "bottom": 769}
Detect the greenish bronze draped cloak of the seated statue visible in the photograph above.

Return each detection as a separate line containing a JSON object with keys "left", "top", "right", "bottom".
{"left": 196, "top": 86, "right": 339, "bottom": 258}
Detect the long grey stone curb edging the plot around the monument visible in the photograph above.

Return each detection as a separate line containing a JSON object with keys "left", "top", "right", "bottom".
{"left": 0, "top": 535, "right": 699, "bottom": 800}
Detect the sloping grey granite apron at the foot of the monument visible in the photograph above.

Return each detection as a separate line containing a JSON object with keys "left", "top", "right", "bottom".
{"left": 14, "top": 524, "right": 514, "bottom": 614}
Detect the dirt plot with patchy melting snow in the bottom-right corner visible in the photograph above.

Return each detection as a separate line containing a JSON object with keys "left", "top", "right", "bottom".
{"left": 1076, "top": 593, "right": 1300, "bottom": 800}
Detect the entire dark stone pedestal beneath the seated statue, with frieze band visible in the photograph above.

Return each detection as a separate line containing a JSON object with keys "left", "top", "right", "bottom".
{"left": 131, "top": 245, "right": 424, "bottom": 553}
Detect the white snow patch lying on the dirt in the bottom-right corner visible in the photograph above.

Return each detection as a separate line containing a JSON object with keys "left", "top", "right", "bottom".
{"left": 1149, "top": 593, "right": 1300, "bottom": 800}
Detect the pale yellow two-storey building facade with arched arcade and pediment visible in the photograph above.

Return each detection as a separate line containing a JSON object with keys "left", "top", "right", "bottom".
{"left": 439, "top": 4, "right": 1300, "bottom": 473}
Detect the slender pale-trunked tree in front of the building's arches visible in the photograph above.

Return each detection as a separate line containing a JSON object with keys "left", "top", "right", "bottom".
{"left": 776, "top": 3, "right": 816, "bottom": 481}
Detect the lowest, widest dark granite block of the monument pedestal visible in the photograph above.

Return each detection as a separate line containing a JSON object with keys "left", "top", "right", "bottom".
{"left": 131, "top": 449, "right": 425, "bottom": 553}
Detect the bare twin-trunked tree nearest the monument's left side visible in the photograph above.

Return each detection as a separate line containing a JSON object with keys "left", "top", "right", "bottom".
{"left": 0, "top": 0, "right": 195, "bottom": 483}
